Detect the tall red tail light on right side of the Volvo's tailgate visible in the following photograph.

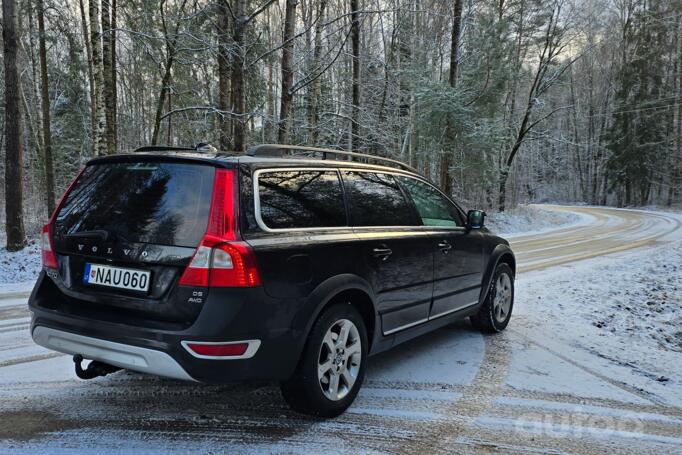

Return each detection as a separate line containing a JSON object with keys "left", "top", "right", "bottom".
{"left": 180, "top": 169, "right": 261, "bottom": 287}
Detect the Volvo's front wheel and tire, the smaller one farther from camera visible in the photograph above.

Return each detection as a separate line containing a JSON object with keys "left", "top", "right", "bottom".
{"left": 471, "top": 263, "right": 514, "bottom": 333}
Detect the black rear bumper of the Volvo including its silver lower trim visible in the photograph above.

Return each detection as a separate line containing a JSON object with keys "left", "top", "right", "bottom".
{"left": 29, "top": 273, "right": 305, "bottom": 384}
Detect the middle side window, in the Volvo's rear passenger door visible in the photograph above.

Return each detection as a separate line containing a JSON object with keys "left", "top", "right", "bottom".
{"left": 343, "top": 172, "right": 417, "bottom": 226}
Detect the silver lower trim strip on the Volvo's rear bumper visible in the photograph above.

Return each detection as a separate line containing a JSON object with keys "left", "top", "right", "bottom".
{"left": 32, "top": 326, "right": 194, "bottom": 381}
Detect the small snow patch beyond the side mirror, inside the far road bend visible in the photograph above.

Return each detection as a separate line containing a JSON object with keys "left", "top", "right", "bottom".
{"left": 486, "top": 205, "right": 590, "bottom": 236}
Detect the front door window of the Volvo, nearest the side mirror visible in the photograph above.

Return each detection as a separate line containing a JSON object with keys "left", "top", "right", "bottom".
{"left": 398, "top": 177, "right": 462, "bottom": 226}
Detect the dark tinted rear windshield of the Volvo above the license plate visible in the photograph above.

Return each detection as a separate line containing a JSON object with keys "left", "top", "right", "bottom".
{"left": 54, "top": 162, "right": 215, "bottom": 247}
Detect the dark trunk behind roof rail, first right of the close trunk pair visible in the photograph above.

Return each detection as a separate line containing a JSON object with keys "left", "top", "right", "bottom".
{"left": 277, "top": 0, "right": 298, "bottom": 143}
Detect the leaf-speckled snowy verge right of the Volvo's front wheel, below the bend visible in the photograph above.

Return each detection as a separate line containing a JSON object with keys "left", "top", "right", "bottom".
{"left": 509, "top": 241, "right": 682, "bottom": 406}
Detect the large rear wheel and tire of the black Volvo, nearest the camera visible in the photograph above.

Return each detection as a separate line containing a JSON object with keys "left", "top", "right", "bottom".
{"left": 280, "top": 303, "right": 368, "bottom": 418}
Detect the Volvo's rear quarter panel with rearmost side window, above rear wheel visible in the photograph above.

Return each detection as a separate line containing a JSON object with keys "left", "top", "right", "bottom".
{"left": 241, "top": 168, "right": 358, "bottom": 300}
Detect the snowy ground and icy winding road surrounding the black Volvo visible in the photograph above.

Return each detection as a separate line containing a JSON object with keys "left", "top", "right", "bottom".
{"left": 0, "top": 206, "right": 682, "bottom": 454}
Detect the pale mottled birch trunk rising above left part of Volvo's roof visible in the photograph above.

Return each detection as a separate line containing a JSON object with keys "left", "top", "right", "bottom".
{"left": 90, "top": 0, "right": 107, "bottom": 156}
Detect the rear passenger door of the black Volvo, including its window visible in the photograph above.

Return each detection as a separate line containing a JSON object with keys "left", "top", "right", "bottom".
{"left": 342, "top": 171, "right": 433, "bottom": 335}
